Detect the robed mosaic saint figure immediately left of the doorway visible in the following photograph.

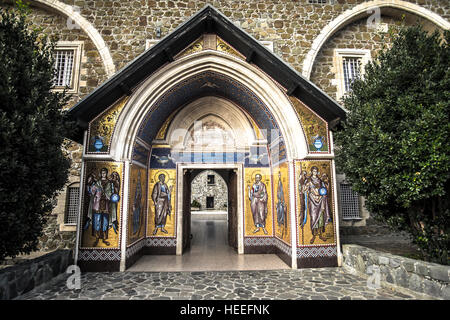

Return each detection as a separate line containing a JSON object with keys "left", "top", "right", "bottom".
{"left": 152, "top": 174, "right": 173, "bottom": 235}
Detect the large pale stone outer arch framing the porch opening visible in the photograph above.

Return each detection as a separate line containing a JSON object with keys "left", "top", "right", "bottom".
{"left": 110, "top": 50, "right": 308, "bottom": 161}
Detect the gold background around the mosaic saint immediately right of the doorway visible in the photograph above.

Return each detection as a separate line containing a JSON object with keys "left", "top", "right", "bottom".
{"left": 244, "top": 168, "right": 273, "bottom": 236}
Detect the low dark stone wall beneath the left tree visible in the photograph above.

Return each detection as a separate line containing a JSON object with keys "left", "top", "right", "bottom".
{"left": 0, "top": 250, "right": 73, "bottom": 300}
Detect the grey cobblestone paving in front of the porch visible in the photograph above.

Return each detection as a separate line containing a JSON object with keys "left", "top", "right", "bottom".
{"left": 19, "top": 268, "right": 421, "bottom": 300}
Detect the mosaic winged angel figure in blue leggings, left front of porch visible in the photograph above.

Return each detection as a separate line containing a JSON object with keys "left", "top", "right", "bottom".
{"left": 84, "top": 168, "right": 120, "bottom": 247}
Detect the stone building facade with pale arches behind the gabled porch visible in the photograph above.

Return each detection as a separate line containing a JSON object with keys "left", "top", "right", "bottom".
{"left": 1, "top": 0, "right": 450, "bottom": 255}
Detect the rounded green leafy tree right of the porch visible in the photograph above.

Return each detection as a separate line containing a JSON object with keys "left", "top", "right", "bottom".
{"left": 336, "top": 26, "right": 450, "bottom": 264}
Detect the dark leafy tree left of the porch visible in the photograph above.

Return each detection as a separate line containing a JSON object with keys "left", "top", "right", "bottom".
{"left": 0, "top": 1, "right": 72, "bottom": 260}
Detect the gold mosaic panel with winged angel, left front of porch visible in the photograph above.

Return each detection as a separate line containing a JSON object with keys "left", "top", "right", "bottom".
{"left": 80, "top": 161, "right": 123, "bottom": 249}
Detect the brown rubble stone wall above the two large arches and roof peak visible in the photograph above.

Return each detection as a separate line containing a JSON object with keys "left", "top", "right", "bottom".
{"left": 52, "top": 0, "right": 450, "bottom": 77}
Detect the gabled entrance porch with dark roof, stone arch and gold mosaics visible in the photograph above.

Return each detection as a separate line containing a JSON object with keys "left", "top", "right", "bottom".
{"left": 70, "top": 6, "right": 345, "bottom": 271}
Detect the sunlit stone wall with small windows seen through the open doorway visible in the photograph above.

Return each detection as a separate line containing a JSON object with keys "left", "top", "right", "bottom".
{"left": 191, "top": 170, "right": 228, "bottom": 210}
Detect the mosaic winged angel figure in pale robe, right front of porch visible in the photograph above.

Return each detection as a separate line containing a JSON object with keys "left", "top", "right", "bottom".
{"left": 299, "top": 166, "right": 331, "bottom": 244}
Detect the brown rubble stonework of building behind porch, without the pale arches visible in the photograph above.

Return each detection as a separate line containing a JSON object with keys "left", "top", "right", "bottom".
{"left": 1, "top": 0, "right": 450, "bottom": 247}
